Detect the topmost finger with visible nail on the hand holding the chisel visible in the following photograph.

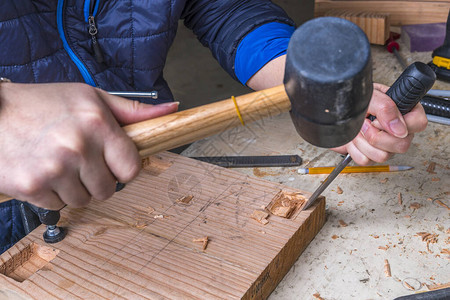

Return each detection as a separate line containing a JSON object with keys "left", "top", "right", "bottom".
{"left": 368, "top": 90, "right": 408, "bottom": 138}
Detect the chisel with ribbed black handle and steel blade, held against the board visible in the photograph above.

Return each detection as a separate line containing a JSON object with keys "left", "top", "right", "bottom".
{"left": 303, "top": 62, "right": 436, "bottom": 209}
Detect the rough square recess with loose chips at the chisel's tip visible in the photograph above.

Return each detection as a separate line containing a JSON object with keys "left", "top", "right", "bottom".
{"left": 267, "top": 191, "right": 306, "bottom": 219}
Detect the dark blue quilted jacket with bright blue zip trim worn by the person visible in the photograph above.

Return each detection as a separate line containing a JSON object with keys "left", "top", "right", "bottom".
{"left": 0, "top": 0, "right": 293, "bottom": 253}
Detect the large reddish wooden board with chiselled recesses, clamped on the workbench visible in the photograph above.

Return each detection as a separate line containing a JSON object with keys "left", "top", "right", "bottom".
{"left": 0, "top": 153, "right": 325, "bottom": 299}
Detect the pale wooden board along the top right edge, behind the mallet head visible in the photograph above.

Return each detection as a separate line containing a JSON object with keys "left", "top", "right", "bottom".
{"left": 314, "top": 0, "right": 450, "bottom": 26}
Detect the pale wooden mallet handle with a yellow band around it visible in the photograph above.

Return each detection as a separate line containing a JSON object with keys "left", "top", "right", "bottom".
{"left": 0, "top": 85, "right": 291, "bottom": 203}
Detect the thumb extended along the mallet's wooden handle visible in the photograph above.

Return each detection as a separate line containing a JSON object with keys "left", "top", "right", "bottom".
{"left": 102, "top": 93, "right": 179, "bottom": 125}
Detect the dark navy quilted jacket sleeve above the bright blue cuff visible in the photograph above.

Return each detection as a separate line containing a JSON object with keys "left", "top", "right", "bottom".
{"left": 181, "top": 0, "right": 295, "bottom": 80}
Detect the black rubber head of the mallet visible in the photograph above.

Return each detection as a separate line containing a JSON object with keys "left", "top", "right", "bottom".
{"left": 284, "top": 17, "right": 373, "bottom": 148}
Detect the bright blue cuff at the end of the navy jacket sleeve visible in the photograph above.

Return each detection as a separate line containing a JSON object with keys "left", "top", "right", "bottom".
{"left": 234, "top": 22, "right": 295, "bottom": 85}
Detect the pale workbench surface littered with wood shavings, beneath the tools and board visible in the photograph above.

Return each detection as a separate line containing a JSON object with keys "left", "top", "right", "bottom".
{"left": 183, "top": 43, "right": 450, "bottom": 300}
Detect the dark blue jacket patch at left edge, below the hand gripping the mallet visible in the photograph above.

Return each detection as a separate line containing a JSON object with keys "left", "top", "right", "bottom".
{"left": 0, "top": 200, "right": 25, "bottom": 254}
